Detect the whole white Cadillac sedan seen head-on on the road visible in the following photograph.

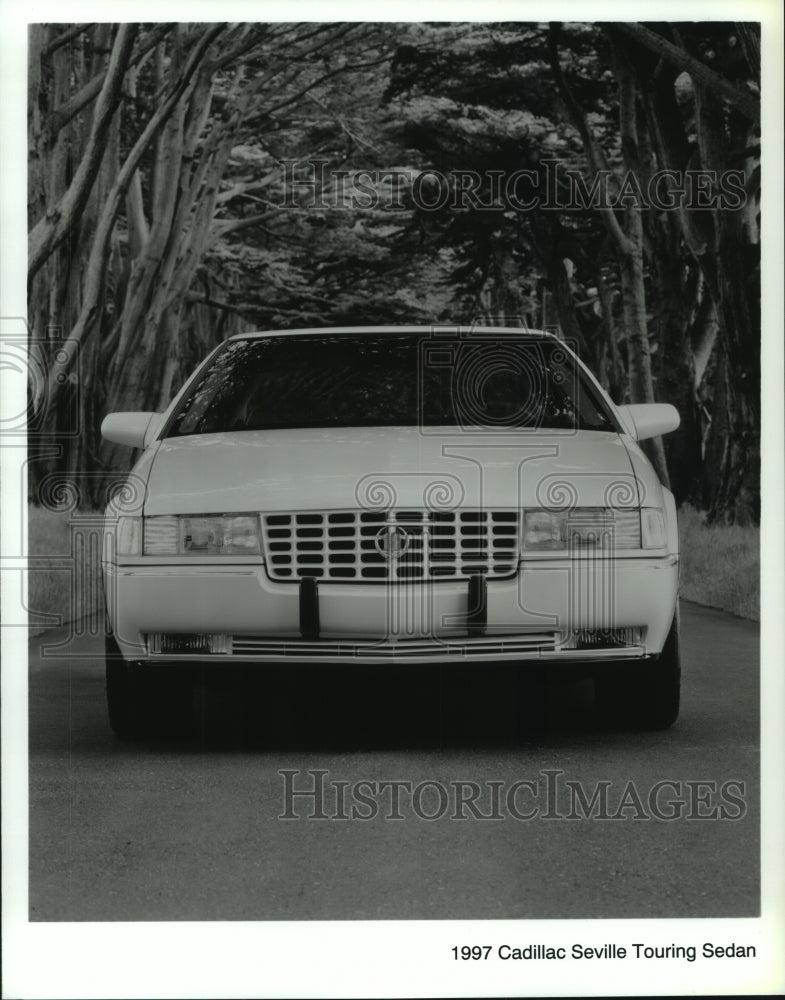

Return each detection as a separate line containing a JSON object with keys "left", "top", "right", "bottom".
{"left": 101, "top": 327, "right": 680, "bottom": 736}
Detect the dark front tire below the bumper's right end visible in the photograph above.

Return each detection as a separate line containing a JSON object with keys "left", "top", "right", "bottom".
{"left": 594, "top": 611, "right": 681, "bottom": 729}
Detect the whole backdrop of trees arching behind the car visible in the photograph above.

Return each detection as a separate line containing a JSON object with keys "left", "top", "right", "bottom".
{"left": 29, "top": 22, "right": 760, "bottom": 520}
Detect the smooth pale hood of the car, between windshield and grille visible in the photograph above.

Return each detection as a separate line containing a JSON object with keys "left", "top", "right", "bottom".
{"left": 145, "top": 427, "right": 648, "bottom": 515}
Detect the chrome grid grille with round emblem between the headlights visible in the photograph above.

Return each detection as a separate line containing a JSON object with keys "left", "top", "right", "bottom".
{"left": 262, "top": 510, "right": 520, "bottom": 582}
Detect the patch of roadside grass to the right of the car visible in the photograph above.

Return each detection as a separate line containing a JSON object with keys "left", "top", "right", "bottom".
{"left": 679, "top": 506, "right": 760, "bottom": 621}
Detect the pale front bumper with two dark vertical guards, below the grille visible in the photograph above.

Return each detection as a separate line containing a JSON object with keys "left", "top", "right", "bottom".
{"left": 103, "top": 555, "right": 678, "bottom": 664}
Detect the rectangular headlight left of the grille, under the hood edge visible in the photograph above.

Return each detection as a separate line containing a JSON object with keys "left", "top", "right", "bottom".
{"left": 143, "top": 514, "right": 262, "bottom": 556}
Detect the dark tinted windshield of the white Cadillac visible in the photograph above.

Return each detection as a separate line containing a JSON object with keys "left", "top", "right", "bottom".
{"left": 167, "top": 331, "right": 615, "bottom": 436}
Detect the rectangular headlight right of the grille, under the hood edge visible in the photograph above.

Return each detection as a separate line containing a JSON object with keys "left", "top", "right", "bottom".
{"left": 521, "top": 507, "right": 641, "bottom": 552}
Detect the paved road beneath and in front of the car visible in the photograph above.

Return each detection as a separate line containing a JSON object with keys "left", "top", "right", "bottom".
{"left": 30, "top": 604, "right": 759, "bottom": 921}
